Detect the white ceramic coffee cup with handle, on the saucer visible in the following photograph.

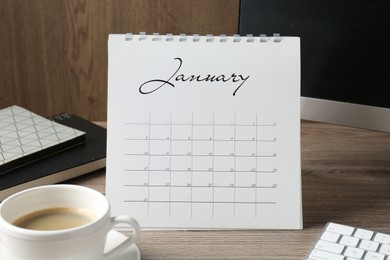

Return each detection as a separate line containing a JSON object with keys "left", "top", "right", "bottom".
{"left": 0, "top": 184, "right": 140, "bottom": 260}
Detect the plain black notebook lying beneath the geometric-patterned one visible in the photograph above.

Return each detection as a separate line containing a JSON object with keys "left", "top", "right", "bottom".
{"left": 0, "top": 113, "right": 107, "bottom": 200}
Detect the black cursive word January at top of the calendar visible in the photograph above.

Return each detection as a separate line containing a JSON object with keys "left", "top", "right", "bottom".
{"left": 139, "top": 58, "right": 249, "bottom": 96}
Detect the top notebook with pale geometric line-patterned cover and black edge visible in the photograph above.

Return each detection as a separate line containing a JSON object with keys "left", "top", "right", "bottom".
{"left": 0, "top": 106, "right": 85, "bottom": 174}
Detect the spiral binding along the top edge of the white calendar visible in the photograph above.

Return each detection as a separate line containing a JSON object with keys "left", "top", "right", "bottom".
{"left": 125, "top": 32, "right": 282, "bottom": 43}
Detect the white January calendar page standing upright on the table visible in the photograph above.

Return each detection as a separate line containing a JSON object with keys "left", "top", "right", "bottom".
{"left": 106, "top": 35, "right": 302, "bottom": 229}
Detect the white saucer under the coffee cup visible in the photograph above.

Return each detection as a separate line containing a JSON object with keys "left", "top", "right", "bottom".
{"left": 0, "top": 230, "right": 141, "bottom": 260}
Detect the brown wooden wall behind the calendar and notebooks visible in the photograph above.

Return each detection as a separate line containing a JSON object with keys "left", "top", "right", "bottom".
{"left": 0, "top": 0, "right": 239, "bottom": 120}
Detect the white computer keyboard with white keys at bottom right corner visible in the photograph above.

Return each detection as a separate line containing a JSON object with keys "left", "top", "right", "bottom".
{"left": 306, "top": 223, "right": 390, "bottom": 260}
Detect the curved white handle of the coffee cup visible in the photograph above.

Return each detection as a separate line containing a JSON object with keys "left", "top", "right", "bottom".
{"left": 104, "top": 215, "right": 141, "bottom": 259}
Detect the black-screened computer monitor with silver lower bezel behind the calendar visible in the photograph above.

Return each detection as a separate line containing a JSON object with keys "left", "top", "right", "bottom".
{"left": 239, "top": 0, "right": 390, "bottom": 132}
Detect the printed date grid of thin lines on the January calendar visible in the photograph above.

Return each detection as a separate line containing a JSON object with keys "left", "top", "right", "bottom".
{"left": 123, "top": 113, "right": 278, "bottom": 218}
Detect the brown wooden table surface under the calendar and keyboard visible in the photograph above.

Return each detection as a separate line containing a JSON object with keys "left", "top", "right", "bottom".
{"left": 70, "top": 121, "right": 390, "bottom": 260}
